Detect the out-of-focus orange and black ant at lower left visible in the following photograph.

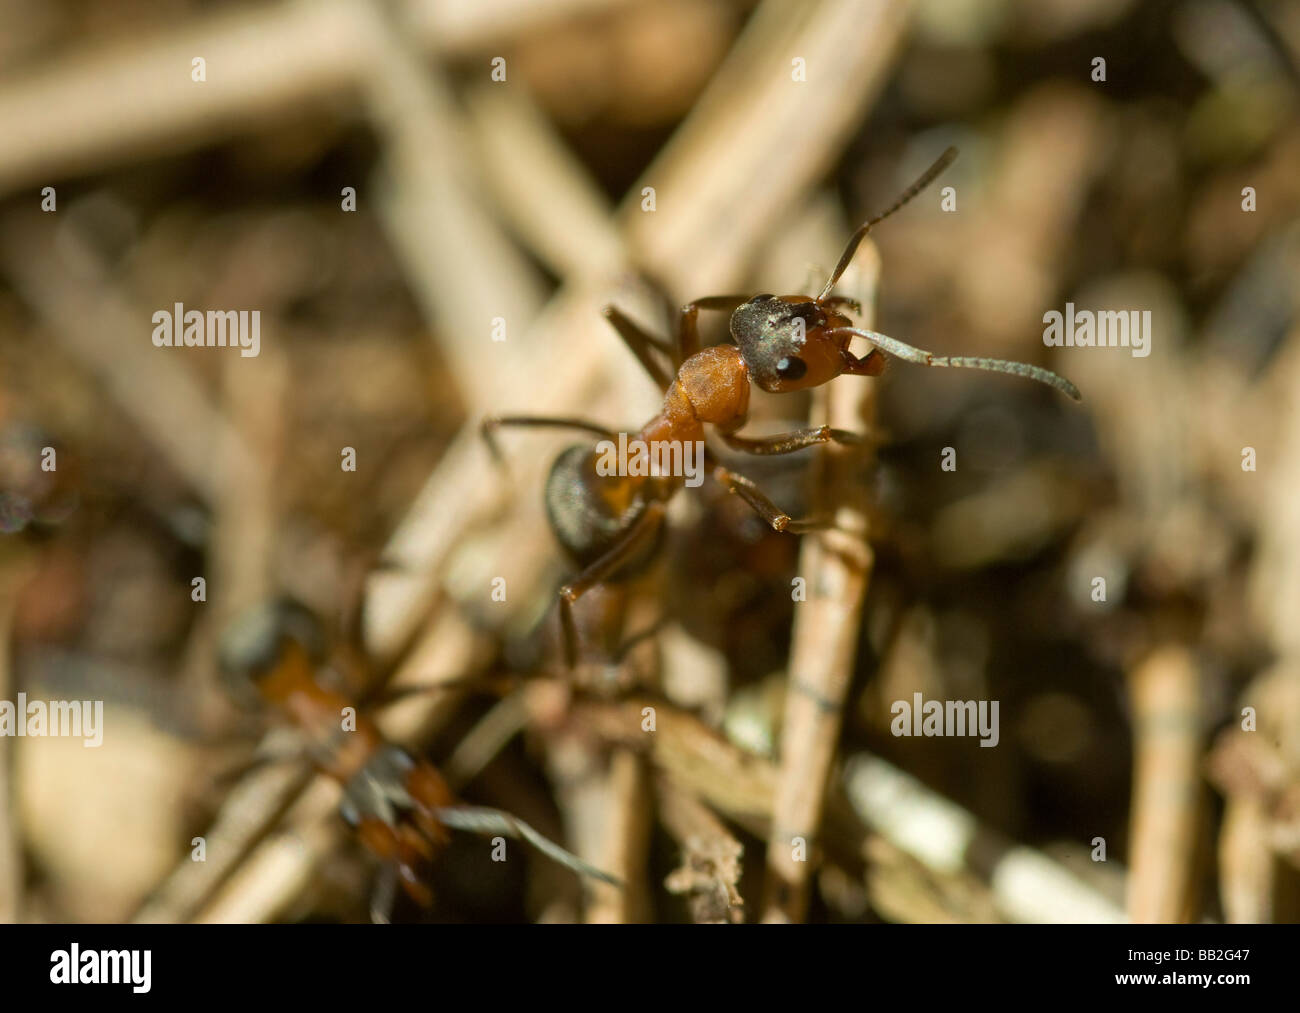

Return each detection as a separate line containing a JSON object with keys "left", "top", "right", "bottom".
{"left": 220, "top": 598, "right": 621, "bottom": 922}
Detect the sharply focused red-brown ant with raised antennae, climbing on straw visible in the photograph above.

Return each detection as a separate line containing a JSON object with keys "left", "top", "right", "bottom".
{"left": 482, "top": 142, "right": 1082, "bottom": 667}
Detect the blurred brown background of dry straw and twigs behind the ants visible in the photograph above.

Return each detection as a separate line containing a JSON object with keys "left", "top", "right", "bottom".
{"left": 0, "top": 0, "right": 1300, "bottom": 921}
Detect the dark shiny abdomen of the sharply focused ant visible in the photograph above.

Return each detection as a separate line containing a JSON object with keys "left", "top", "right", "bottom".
{"left": 546, "top": 443, "right": 658, "bottom": 573}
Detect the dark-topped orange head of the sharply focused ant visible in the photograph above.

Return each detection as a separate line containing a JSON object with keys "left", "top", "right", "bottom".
{"left": 731, "top": 295, "right": 850, "bottom": 394}
